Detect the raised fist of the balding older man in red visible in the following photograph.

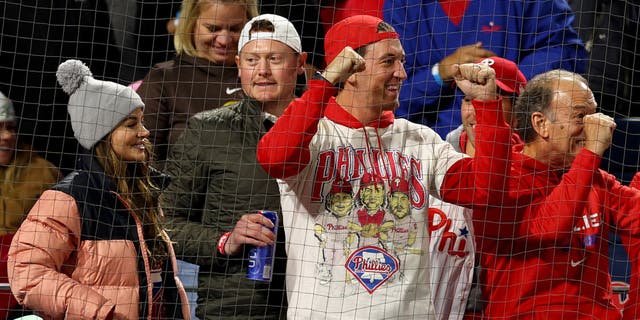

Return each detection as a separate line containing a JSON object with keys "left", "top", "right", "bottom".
{"left": 583, "top": 113, "right": 616, "bottom": 156}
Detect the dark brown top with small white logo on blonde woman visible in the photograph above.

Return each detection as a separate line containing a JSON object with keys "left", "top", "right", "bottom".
{"left": 138, "top": 55, "right": 241, "bottom": 169}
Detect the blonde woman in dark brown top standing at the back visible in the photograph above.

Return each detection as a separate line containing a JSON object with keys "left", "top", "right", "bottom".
{"left": 138, "top": 0, "right": 258, "bottom": 169}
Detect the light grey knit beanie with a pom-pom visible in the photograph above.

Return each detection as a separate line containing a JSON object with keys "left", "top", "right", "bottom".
{"left": 56, "top": 60, "right": 144, "bottom": 149}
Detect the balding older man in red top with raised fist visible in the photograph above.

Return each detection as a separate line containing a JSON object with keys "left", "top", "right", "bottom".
{"left": 474, "top": 70, "right": 640, "bottom": 319}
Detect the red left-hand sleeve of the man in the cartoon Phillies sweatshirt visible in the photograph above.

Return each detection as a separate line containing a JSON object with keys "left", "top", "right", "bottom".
{"left": 257, "top": 80, "right": 337, "bottom": 178}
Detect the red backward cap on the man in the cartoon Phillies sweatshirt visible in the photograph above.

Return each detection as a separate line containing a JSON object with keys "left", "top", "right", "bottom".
{"left": 324, "top": 15, "right": 400, "bottom": 65}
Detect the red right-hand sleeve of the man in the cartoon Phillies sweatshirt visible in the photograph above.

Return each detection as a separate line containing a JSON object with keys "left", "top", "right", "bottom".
{"left": 440, "top": 98, "right": 511, "bottom": 207}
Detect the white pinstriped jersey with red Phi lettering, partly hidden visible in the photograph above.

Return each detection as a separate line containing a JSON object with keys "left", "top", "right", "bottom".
{"left": 429, "top": 198, "right": 475, "bottom": 320}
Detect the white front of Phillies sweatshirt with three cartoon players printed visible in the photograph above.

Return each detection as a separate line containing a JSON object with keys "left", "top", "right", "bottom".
{"left": 279, "top": 118, "right": 465, "bottom": 319}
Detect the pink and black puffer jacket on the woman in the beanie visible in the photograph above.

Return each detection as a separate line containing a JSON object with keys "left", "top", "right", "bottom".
{"left": 8, "top": 155, "right": 190, "bottom": 319}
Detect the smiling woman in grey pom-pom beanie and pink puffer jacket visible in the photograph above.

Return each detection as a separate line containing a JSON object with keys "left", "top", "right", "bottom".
{"left": 8, "top": 60, "right": 189, "bottom": 319}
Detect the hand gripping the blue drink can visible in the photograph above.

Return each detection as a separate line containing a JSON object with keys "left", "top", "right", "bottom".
{"left": 224, "top": 213, "right": 276, "bottom": 255}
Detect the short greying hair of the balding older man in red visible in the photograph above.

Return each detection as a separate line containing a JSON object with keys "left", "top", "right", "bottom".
{"left": 513, "top": 69, "right": 588, "bottom": 143}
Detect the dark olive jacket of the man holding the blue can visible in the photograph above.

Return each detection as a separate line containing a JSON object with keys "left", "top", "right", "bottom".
{"left": 162, "top": 99, "right": 286, "bottom": 319}
